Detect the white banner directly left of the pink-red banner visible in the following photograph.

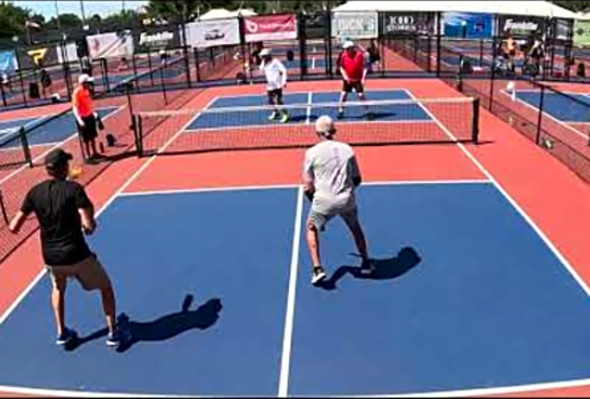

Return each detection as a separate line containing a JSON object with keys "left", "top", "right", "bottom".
{"left": 186, "top": 18, "right": 240, "bottom": 48}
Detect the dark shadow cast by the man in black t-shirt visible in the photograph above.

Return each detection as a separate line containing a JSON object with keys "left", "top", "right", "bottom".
{"left": 65, "top": 295, "right": 223, "bottom": 353}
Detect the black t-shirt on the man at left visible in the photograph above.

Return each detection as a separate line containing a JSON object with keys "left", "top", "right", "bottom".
{"left": 21, "top": 179, "right": 92, "bottom": 266}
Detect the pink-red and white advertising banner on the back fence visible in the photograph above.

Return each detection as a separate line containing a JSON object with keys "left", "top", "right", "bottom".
{"left": 244, "top": 14, "right": 297, "bottom": 42}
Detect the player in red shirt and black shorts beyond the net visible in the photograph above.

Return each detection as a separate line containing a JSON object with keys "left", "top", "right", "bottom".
{"left": 338, "top": 41, "right": 370, "bottom": 118}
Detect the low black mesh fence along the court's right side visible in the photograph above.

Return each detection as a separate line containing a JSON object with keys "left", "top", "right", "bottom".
{"left": 444, "top": 50, "right": 590, "bottom": 183}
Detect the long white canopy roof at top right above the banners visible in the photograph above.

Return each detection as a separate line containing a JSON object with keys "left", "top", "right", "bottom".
{"left": 332, "top": 0, "right": 579, "bottom": 19}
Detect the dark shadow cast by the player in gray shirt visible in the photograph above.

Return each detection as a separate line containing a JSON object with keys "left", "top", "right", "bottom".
{"left": 318, "top": 247, "right": 422, "bottom": 291}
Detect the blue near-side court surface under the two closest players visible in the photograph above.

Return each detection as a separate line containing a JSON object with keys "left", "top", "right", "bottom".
{"left": 0, "top": 182, "right": 590, "bottom": 396}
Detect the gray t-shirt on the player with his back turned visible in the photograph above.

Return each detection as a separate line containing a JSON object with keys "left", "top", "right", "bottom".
{"left": 303, "top": 140, "right": 361, "bottom": 214}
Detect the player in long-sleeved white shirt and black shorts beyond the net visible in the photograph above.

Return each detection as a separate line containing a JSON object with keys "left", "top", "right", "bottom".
{"left": 260, "top": 49, "right": 289, "bottom": 123}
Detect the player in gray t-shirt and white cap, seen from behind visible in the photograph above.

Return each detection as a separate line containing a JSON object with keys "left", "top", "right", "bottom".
{"left": 303, "top": 115, "right": 373, "bottom": 285}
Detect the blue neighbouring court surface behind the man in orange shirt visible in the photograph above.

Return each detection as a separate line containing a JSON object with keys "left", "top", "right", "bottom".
{"left": 0, "top": 107, "right": 118, "bottom": 148}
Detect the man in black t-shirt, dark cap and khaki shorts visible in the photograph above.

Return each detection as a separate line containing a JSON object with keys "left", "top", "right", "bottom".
{"left": 10, "top": 149, "right": 119, "bottom": 346}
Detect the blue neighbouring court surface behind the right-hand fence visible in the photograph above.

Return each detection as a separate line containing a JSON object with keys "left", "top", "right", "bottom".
{"left": 516, "top": 90, "right": 590, "bottom": 123}
